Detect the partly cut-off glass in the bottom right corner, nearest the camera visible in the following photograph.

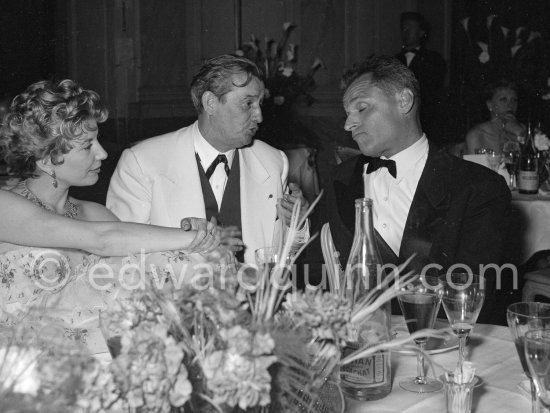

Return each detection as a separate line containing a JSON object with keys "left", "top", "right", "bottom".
{"left": 524, "top": 329, "right": 550, "bottom": 408}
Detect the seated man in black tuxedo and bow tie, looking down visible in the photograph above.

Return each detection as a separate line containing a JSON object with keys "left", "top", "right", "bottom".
{"left": 326, "top": 56, "right": 510, "bottom": 322}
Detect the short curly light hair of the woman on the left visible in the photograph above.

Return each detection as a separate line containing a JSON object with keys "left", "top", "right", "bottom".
{"left": 0, "top": 79, "right": 109, "bottom": 178}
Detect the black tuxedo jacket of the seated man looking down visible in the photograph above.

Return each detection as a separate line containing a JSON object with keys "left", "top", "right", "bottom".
{"left": 326, "top": 144, "right": 510, "bottom": 322}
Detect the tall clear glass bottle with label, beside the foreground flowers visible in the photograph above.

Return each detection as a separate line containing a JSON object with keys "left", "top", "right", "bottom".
{"left": 340, "top": 198, "right": 392, "bottom": 400}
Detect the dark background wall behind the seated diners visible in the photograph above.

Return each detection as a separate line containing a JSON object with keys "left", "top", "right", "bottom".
{"left": 0, "top": 0, "right": 550, "bottom": 204}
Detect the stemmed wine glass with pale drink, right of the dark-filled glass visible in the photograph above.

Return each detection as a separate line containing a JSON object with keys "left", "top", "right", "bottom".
{"left": 440, "top": 272, "right": 485, "bottom": 380}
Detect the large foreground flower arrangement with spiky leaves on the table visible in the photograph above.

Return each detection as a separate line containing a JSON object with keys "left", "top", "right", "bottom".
{"left": 0, "top": 194, "right": 446, "bottom": 413}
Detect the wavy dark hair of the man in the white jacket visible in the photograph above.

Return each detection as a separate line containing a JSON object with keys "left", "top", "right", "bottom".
{"left": 191, "top": 55, "right": 262, "bottom": 114}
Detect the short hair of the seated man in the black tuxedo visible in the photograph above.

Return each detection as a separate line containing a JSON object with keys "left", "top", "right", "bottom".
{"left": 341, "top": 55, "right": 420, "bottom": 101}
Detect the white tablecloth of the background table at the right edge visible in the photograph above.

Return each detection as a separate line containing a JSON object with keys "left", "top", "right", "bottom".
{"left": 505, "top": 191, "right": 550, "bottom": 265}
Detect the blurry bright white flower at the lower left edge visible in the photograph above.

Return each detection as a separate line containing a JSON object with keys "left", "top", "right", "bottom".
{"left": 0, "top": 346, "right": 40, "bottom": 396}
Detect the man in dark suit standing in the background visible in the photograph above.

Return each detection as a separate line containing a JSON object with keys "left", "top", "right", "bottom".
{"left": 396, "top": 12, "right": 447, "bottom": 140}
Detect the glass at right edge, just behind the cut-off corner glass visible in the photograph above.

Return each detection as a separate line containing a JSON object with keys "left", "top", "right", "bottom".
{"left": 506, "top": 302, "right": 550, "bottom": 413}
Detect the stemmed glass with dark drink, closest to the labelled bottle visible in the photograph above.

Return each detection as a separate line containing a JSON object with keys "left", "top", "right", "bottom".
{"left": 397, "top": 276, "right": 443, "bottom": 393}
